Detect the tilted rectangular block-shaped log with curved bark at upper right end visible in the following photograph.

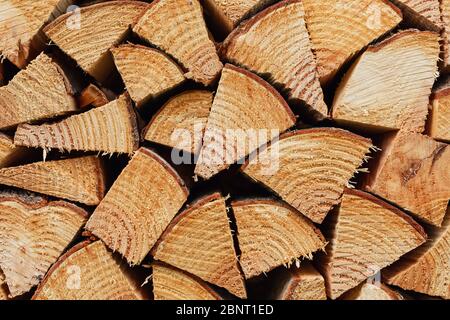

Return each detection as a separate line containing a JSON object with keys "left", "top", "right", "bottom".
{"left": 86, "top": 148, "right": 188, "bottom": 265}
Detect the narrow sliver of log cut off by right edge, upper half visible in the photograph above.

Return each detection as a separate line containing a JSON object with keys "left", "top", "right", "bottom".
{"left": 429, "top": 79, "right": 450, "bottom": 142}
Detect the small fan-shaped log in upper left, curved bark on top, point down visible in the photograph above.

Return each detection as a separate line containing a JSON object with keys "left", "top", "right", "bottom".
{"left": 111, "top": 44, "right": 185, "bottom": 106}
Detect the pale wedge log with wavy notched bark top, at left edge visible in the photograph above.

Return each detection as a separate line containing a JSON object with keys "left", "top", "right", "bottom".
{"left": 0, "top": 194, "right": 87, "bottom": 297}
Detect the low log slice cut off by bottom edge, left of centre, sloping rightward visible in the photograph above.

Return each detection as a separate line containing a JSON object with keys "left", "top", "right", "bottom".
{"left": 152, "top": 263, "right": 221, "bottom": 301}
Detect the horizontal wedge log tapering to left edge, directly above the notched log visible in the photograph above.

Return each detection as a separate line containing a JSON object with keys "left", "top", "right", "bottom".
{"left": 0, "top": 157, "right": 105, "bottom": 205}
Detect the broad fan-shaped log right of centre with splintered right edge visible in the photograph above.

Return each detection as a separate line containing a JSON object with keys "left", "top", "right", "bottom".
{"left": 242, "top": 128, "right": 372, "bottom": 223}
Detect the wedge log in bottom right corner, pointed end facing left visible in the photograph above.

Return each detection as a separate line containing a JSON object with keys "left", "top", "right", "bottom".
{"left": 383, "top": 209, "right": 450, "bottom": 299}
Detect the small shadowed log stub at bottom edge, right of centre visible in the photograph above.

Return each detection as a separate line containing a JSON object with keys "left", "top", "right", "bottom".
{"left": 274, "top": 263, "right": 327, "bottom": 301}
